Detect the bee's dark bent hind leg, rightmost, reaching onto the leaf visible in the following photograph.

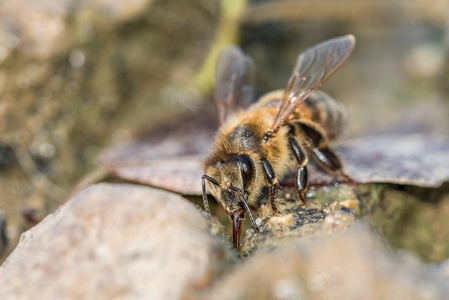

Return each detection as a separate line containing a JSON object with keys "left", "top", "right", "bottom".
{"left": 294, "top": 120, "right": 354, "bottom": 183}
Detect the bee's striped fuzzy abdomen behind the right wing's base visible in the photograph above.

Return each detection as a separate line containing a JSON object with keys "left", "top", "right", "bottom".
{"left": 297, "top": 91, "right": 347, "bottom": 139}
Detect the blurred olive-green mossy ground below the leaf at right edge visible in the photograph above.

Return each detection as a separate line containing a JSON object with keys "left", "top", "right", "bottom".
{"left": 358, "top": 184, "right": 449, "bottom": 262}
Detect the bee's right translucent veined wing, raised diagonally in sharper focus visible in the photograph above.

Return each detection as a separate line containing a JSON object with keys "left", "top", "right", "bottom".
{"left": 269, "top": 34, "right": 355, "bottom": 133}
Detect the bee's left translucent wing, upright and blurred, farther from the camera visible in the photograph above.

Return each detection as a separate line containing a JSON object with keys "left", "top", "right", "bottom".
{"left": 214, "top": 45, "right": 254, "bottom": 123}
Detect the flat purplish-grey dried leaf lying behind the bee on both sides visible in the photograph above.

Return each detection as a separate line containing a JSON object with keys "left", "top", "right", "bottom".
{"left": 104, "top": 135, "right": 449, "bottom": 195}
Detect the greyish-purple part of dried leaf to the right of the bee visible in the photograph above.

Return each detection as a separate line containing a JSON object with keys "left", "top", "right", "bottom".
{"left": 338, "top": 135, "right": 449, "bottom": 187}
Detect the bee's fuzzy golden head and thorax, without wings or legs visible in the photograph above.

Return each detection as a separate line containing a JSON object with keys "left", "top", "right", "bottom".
{"left": 205, "top": 105, "right": 290, "bottom": 213}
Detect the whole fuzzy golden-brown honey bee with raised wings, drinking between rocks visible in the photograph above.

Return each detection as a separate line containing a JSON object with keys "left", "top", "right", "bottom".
{"left": 202, "top": 35, "right": 355, "bottom": 249}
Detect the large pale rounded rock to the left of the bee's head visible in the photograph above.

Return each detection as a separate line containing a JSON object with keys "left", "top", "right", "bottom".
{"left": 0, "top": 184, "right": 232, "bottom": 299}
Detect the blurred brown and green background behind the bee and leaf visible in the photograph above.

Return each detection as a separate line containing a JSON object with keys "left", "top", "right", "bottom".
{"left": 0, "top": 0, "right": 449, "bottom": 258}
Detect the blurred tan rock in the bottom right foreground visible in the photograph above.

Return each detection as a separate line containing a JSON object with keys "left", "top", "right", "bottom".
{"left": 202, "top": 224, "right": 449, "bottom": 299}
